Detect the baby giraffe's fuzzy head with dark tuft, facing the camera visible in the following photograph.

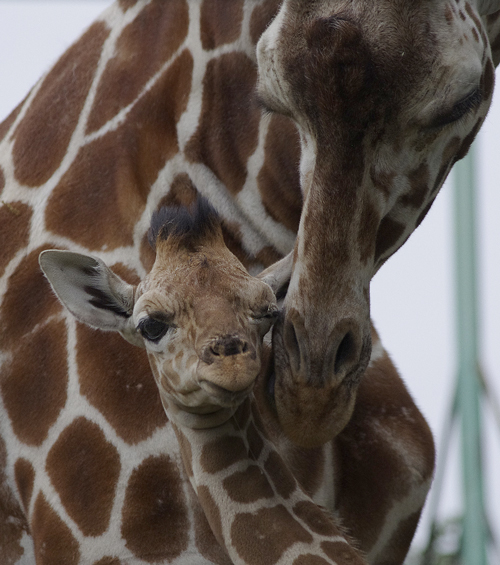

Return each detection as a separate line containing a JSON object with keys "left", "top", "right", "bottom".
{"left": 40, "top": 200, "right": 278, "bottom": 428}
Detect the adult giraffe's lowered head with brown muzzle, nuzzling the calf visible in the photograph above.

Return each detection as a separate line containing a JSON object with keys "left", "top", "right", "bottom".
{"left": 258, "top": 0, "right": 500, "bottom": 445}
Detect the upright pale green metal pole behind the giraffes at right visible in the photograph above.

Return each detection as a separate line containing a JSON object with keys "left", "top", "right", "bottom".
{"left": 454, "top": 146, "right": 487, "bottom": 565}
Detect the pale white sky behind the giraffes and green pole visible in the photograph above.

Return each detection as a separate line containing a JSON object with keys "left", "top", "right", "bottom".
{"left": 0, "top": 0, "right": 500, "bottom": 556}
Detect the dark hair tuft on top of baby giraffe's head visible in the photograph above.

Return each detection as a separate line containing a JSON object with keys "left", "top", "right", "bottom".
{"left": 148, "top": 196, "right": 220, "bottom": 249}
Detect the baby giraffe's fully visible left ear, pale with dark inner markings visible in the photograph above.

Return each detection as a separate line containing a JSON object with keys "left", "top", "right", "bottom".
{"left": 39, "top": 250, "right": 134, "bottom": 333}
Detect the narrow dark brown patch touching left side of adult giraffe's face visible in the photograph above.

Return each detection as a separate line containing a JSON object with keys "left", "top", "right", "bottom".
{"left": 257, "top": 115, "right": 302, "bottom": 232}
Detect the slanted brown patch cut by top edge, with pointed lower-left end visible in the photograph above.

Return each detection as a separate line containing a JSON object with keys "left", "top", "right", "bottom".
{"left": 87, "top": 0, "right": 189, "bottom": 133}
